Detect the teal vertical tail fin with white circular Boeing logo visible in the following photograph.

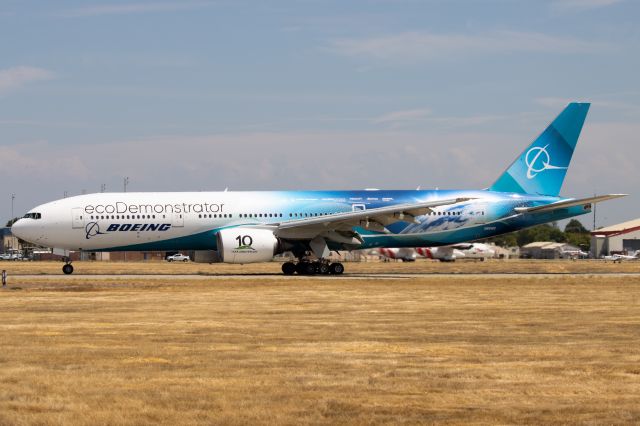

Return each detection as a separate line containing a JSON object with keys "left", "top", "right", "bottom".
{"left": 489, "top": 103, "right": 591, "bottom": 196}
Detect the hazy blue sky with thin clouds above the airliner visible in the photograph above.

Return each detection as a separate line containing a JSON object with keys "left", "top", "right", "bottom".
{"left": 0, "top": 0, "right": 640, "bottom": 228}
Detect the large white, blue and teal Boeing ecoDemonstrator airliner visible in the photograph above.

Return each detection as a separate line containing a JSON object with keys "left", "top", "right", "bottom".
{"left": 12, "top": 103, "right": 624, "bottom": 274}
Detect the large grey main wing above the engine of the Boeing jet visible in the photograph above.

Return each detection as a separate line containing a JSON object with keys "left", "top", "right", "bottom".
{"left": 276, "top": 198, "right": 471, "bottom": 238}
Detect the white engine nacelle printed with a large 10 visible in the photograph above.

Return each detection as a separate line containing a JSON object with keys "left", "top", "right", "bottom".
{"left": 216, "top": 227, "right": 278, "bottom": 263}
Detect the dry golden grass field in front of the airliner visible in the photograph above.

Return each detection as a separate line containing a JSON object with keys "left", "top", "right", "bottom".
{"left": 0, "top": 262, "right": 640, "bottom": 425}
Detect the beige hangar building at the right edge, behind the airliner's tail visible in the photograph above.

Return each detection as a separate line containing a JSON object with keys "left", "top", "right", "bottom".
{"left": 591, "top": 219, "right": 640, "bottom": 258}
